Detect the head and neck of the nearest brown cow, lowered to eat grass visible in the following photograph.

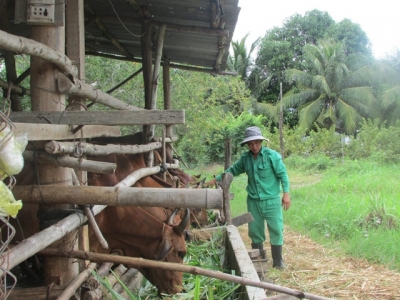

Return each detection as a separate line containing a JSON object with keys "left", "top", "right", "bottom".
{"left": 89, "top": 206, "right": 189, "bottom": 294}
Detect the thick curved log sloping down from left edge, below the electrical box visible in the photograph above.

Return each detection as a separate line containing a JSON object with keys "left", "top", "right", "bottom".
{"left": 0, "top": 30, "right": 78, "bottom": 77}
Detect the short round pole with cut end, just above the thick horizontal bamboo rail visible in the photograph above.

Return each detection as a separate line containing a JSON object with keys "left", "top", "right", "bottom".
{"left": 22, "top": 150, "right": 117, "bottom": 174}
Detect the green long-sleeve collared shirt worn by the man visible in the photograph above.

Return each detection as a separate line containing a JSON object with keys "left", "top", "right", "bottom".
{"left": 216, "top": 146, "right": 289, "bottom": 200}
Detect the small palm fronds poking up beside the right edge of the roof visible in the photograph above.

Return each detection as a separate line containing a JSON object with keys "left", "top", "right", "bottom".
{"left": 228, "top": 34, "right": 260, "bottom": 81}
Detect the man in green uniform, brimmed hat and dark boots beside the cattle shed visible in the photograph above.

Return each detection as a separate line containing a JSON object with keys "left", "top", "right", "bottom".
{"left": 206, "top": 126, "right": 290, "bottom": 268}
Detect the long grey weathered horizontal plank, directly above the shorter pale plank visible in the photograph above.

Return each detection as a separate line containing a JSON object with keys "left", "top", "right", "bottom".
{"left": 9, "top": 109, "right": 185, "bottom": 125}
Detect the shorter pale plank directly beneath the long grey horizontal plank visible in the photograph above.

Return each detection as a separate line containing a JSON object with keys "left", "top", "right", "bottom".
{"left": 14, "top": 123, "right": 121, "bottom": 141}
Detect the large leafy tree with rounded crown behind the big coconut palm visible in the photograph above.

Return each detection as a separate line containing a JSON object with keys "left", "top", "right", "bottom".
{"left": 249, "top": 10, "right": 370, "bottom": 112}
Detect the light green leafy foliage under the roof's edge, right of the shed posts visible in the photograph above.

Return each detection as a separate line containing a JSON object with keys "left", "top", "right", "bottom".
{"left": 171, "top": 70, "right": 250, "bottom": 165}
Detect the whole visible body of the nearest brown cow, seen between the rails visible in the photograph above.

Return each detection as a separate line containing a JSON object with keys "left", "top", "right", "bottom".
{"left": 88, "top": 154, "right": 190, "bottom": 294}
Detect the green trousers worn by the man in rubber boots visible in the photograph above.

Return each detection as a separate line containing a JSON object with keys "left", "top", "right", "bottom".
{"left": 247, "top": 197, "right": 283, "bottom": 246}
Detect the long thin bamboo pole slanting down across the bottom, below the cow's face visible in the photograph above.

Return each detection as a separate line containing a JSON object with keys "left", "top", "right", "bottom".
{"left": 40, "top": 248, "right": 330, "bottom": 300}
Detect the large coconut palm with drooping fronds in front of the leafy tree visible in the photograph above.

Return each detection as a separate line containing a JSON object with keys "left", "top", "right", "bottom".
{"left": 277, "top": 41, "right": 375, "bottom": 134}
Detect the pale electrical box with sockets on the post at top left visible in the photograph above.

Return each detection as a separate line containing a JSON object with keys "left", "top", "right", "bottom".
{"left": 15, "top": 0, "right": 65, "bottom": 26}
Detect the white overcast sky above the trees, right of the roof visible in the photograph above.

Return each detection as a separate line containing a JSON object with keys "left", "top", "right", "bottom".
{"left": 233, "top": 0, "right": 400, "bottom": 58}
